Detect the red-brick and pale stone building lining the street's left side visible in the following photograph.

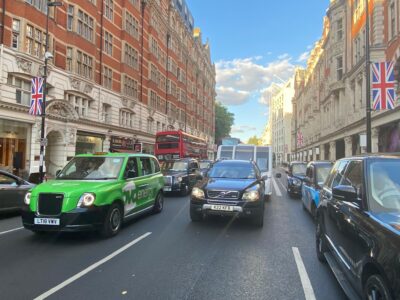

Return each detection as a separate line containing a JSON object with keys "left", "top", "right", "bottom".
{"left": 0, "top": 0, "right": 215, "bottom": 175}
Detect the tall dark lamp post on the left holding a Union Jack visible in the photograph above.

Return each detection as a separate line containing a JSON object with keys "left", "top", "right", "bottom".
{"left": 39, "top": 1, "right": 63, "bottom": 183}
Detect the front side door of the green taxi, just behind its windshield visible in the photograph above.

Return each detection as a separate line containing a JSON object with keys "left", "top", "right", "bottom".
{"left": 123, "top": 157, "right": 146, "bottom": 216}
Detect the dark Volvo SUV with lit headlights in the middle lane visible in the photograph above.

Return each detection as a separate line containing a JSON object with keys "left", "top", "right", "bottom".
{"left": 190, "top": 160, "right": 265, "bottom": 227}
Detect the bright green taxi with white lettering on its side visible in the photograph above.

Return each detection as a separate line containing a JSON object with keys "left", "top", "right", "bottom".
{"left": 22, "top": 153, "right": 164, "bottom": 237}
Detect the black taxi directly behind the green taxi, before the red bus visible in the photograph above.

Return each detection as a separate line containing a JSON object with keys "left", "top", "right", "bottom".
{"left": 161, "top": 158, "right": 203, "bottom": 196}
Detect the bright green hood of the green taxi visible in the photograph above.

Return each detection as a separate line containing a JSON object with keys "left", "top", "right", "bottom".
{"left": 32, "top": 180, "right": 116, "bottom": 198}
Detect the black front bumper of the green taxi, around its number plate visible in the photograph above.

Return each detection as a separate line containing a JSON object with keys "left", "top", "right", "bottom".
{"left": 21, "top": 206, "right": 109, "bottom": 232}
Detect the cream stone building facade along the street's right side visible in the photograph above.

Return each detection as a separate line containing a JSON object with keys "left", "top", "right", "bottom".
{"left": 292, "top": 0, "right": 400, "bottom": 161}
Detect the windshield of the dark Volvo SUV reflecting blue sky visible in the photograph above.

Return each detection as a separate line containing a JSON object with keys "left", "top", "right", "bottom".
{"left": 208, "top": 164, "right": 256, "bottom": 179}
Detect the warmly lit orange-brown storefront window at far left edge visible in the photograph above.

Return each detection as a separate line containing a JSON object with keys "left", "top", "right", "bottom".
{"left": 0, "top": 119, "right": 31, "bottom": 176}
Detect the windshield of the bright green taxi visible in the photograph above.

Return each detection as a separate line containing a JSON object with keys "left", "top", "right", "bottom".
{"left": 56, "top": 156, "right": 124, "bottom": 180}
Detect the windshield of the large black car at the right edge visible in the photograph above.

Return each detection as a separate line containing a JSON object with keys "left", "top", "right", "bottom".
{"left": 368, "top": 160, "right": 400, "bottom": 212}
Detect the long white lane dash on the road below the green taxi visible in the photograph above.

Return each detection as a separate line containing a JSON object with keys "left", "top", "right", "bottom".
{"left": 34, "top": 232, "right": 151, "bottom": 300}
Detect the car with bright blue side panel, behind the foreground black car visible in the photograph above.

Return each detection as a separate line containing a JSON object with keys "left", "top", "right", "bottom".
{"left": 301, "top": 161, "right": 332, "bottom": 218}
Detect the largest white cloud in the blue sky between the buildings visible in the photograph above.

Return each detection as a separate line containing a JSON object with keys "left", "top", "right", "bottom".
{"left": 215, "top": 54, "right": 294, "bottom": 105}
